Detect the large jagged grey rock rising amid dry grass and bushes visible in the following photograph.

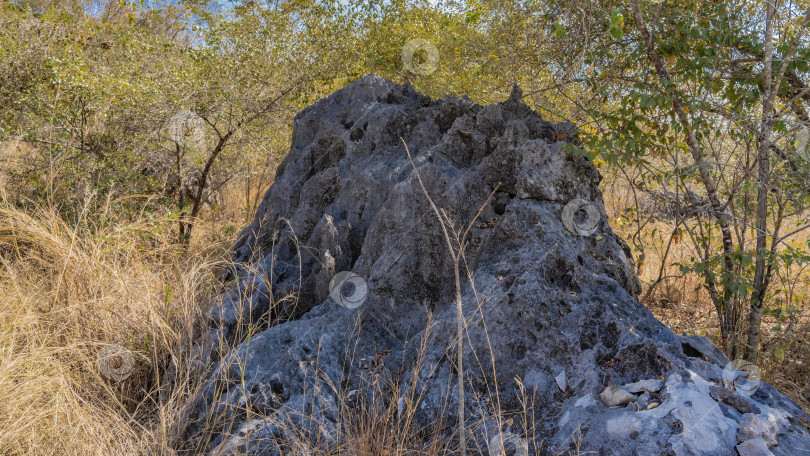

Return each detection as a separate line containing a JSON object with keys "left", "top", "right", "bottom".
{"left": 176, "top": 75, "right": 810, "bottom": 456}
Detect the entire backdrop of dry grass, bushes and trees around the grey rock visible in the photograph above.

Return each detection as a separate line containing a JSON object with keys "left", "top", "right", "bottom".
{"left": 0, "top": 0, "right": 810, "bottom": 455}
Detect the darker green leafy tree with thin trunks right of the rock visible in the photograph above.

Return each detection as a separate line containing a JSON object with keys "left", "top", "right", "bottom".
{"left": 572, "top": 1, "right": 810, "bottom": 356}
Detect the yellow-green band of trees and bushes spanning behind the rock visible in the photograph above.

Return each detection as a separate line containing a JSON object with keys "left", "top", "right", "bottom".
{"left": 0, "top": 0, "right": 810, "bottom": 360}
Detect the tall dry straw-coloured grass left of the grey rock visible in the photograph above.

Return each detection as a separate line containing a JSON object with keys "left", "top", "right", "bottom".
{"left": 0, "top": 195, "right": 230, "bottom": 455}
